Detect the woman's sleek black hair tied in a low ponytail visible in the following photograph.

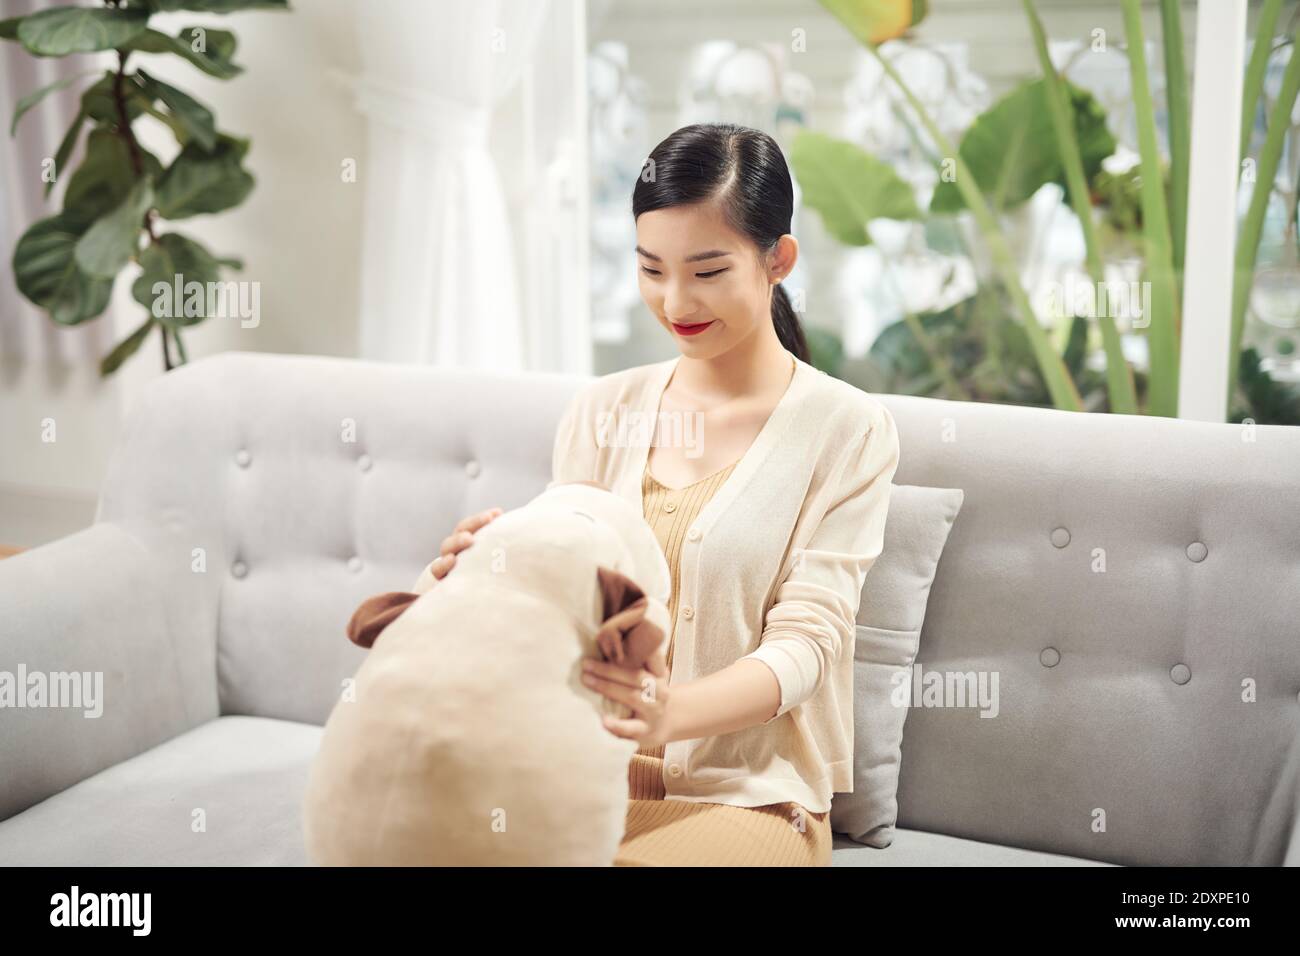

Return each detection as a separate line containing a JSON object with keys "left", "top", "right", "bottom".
{"left": 632, "top": 122, "right": 811, "bottom": 362}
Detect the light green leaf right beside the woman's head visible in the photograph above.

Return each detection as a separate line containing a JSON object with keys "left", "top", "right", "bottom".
{"left": 790, "top": 130, "right": 920, "bottom": 246}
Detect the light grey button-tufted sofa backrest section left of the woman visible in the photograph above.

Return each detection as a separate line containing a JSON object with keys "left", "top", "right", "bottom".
{"left": 98, "top": 352, "right": 573, "bottom": 723}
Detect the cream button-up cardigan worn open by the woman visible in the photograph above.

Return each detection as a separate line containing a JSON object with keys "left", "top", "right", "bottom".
{"left": 547, "top": 356, "right": 898, "bottom": 813}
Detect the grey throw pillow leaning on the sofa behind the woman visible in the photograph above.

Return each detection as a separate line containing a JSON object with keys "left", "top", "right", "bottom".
{"left": 831, "top": 485, "right": 963, "bottom": 847}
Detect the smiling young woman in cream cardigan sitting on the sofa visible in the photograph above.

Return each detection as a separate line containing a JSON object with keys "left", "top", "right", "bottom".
{"left": 430, "top": 124, "right": 898, "bottom": 865}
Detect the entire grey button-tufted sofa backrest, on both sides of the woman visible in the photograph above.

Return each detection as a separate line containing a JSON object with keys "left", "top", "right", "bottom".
{"left": 98, "top": 352, "right": 1300, "bottom": 865}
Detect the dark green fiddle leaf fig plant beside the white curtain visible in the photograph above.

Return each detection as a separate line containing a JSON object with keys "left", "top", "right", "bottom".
{"left": 0, "top": 0, "right": 289, "bottom": 376}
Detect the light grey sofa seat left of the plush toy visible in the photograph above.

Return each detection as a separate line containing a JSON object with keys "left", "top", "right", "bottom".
{"left": 0, "top": 717, "right": 321, "bottom": 866}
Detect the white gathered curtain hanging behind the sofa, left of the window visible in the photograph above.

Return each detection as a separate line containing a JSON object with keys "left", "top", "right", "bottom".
{"left": 355, "top": 0, "right": 551, "bottom": 371}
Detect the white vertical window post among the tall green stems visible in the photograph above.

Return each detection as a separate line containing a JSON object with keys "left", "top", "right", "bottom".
{"left": 1178, "top": 0, "right": 1248, "bottom": 421}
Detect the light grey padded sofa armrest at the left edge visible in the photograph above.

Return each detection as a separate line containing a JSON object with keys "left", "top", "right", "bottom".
{"left": 0, "top": 522, "right": 218, "bottom": 819}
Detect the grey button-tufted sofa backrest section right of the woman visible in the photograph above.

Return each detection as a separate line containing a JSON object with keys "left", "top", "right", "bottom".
{"left": 880, "top": 395, "right": 1300, "bottom": 865}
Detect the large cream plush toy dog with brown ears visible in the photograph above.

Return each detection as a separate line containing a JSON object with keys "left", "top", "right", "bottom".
{"left": 303, "top": 483, "right": 671, "bottom": 866}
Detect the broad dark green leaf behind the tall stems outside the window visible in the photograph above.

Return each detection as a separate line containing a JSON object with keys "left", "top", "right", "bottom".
{"left": 930, "top": 79, "right": 1115, "bottom": 213}
